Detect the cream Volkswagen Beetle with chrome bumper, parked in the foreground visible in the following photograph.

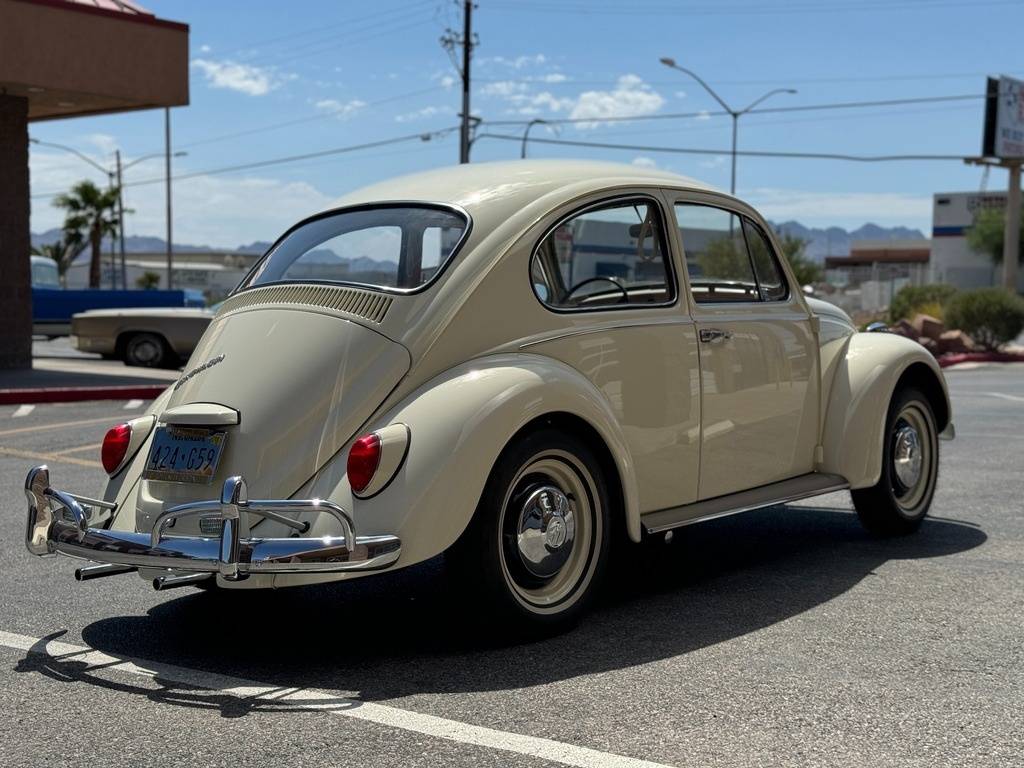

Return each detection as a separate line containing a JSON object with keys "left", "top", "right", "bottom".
{"left": 26, "top": 162, "right": 952, "bottom": 624}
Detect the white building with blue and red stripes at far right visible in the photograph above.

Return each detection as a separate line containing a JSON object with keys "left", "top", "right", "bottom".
{"left": 930, "top": 191, "right": 1024, "bottom": 290}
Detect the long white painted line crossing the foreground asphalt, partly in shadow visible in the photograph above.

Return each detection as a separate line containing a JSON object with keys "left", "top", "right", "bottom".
{"left": 0, "top": 630, "right": 666, "bottom": 768}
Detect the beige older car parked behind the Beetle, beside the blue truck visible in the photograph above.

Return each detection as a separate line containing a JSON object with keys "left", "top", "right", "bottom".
{"left": 71, "top": 307, "right": 213, "bottom": 368}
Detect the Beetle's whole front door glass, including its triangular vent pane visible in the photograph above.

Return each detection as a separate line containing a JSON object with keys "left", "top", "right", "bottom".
{"left": 675, "top": 203, "right": 788, "bottom": 304}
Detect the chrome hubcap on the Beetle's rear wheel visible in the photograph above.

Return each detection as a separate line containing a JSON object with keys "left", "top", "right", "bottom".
{"left": 516, "top": 485, "right": 575, "bottom": 579}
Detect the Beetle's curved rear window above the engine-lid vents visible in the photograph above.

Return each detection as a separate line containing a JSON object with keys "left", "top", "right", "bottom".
{"left": 241, "top": 206, "right": 467, "bottom": 290}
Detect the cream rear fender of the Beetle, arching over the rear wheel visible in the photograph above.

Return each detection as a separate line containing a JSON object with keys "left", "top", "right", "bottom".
{"left": 303, "top": 354, "right": 640, "bottom": 565}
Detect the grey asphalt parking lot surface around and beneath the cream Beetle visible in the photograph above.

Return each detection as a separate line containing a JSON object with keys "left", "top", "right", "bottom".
{"left": 0, "top": 366, "right": 1024, "bottom": 766}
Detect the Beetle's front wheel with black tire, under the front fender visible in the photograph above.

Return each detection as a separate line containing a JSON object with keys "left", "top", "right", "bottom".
{"left": 851, "top": 387, "right": 939, "bottom": 536}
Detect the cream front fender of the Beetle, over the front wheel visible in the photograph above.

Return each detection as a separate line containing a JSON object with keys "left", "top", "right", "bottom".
{"left": 820, "top": 333, "right": 951, "bottom": 488}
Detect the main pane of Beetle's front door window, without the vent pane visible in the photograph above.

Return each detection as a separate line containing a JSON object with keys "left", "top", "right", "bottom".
{"left": 675, "top": 203, "right": 761, "bottom": 304}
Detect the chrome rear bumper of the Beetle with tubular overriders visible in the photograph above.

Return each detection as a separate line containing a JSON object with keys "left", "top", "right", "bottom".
{"left": 25, "top": 466, "right": 401, "bottom": 581}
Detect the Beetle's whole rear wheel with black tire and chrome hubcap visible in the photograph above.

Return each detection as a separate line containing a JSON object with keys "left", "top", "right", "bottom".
{"left": 446, "top": 428, "right": 611, "bottom": 634}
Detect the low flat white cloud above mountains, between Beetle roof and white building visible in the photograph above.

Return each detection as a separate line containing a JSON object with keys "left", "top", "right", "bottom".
{"left": 741, "top": 187, "right": 932, "bottom": 227}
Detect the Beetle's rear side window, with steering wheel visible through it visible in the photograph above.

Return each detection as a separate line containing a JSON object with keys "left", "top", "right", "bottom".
{"left": 529, "top": 200, "right": 675, "bottom": 309}
